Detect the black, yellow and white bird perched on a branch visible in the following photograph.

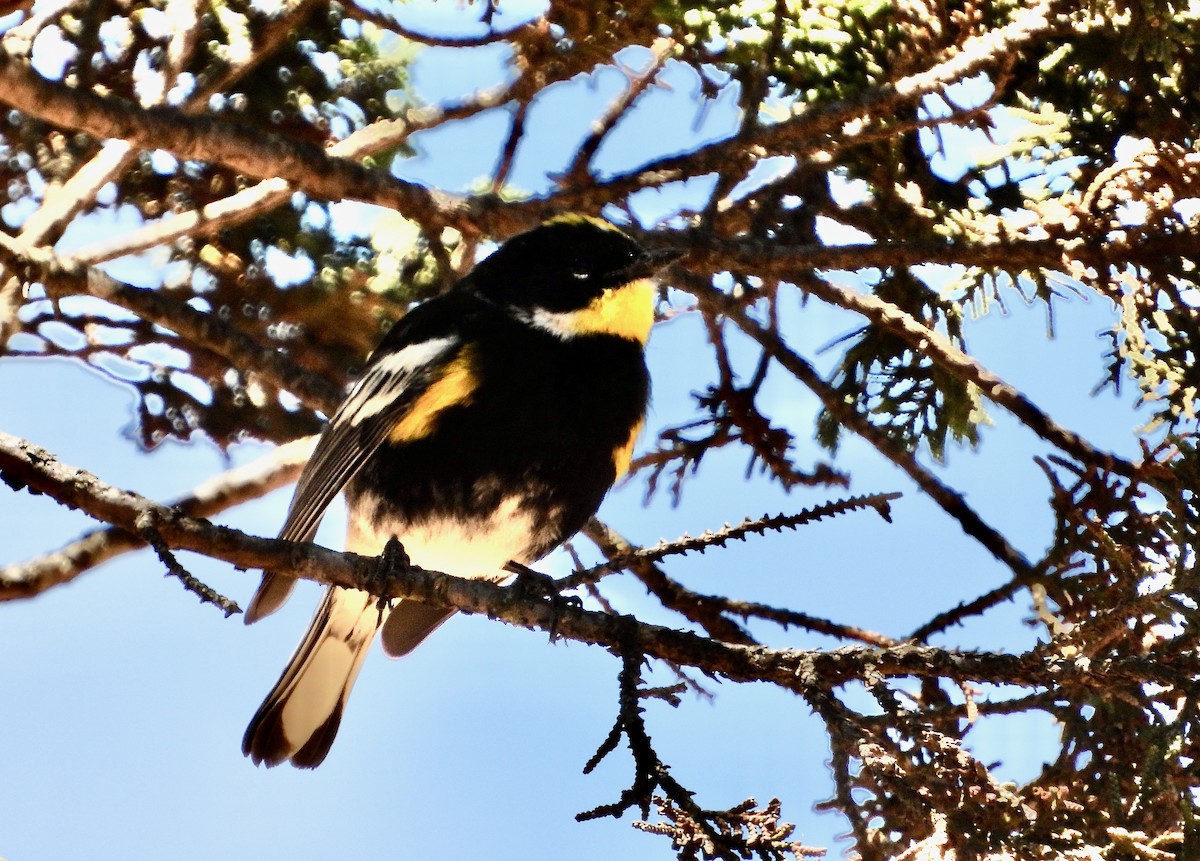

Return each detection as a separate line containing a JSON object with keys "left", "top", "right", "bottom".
{"left": 242, "top": 215, "right": 678, "bottom": 769}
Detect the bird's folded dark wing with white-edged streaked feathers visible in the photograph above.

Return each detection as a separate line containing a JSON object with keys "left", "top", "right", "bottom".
{"left": 245, "top": 294, "right": 479, "bottom": 625}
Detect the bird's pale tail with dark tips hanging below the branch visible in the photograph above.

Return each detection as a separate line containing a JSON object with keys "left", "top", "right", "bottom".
{"left": 241, "top": 586, "right": 386, "bottom": 769}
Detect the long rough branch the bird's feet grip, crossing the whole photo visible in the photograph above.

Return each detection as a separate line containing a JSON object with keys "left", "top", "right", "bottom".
{"left": 0, "top": 432, "right": 1200, "bottom": 697}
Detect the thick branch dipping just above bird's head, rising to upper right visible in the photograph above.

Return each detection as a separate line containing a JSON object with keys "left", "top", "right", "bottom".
{"left": 0, "top": 4, "right": 1070, "bottom": 256}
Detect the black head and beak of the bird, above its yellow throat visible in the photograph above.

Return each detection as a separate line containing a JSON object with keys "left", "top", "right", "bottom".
{"left": 458, "top": 215, "right": 679, "bottom": 312}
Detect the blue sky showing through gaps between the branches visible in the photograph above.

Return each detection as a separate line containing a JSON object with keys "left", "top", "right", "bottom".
{"left": 0, "top": 2, "right": 1152, "bottom": 861}
